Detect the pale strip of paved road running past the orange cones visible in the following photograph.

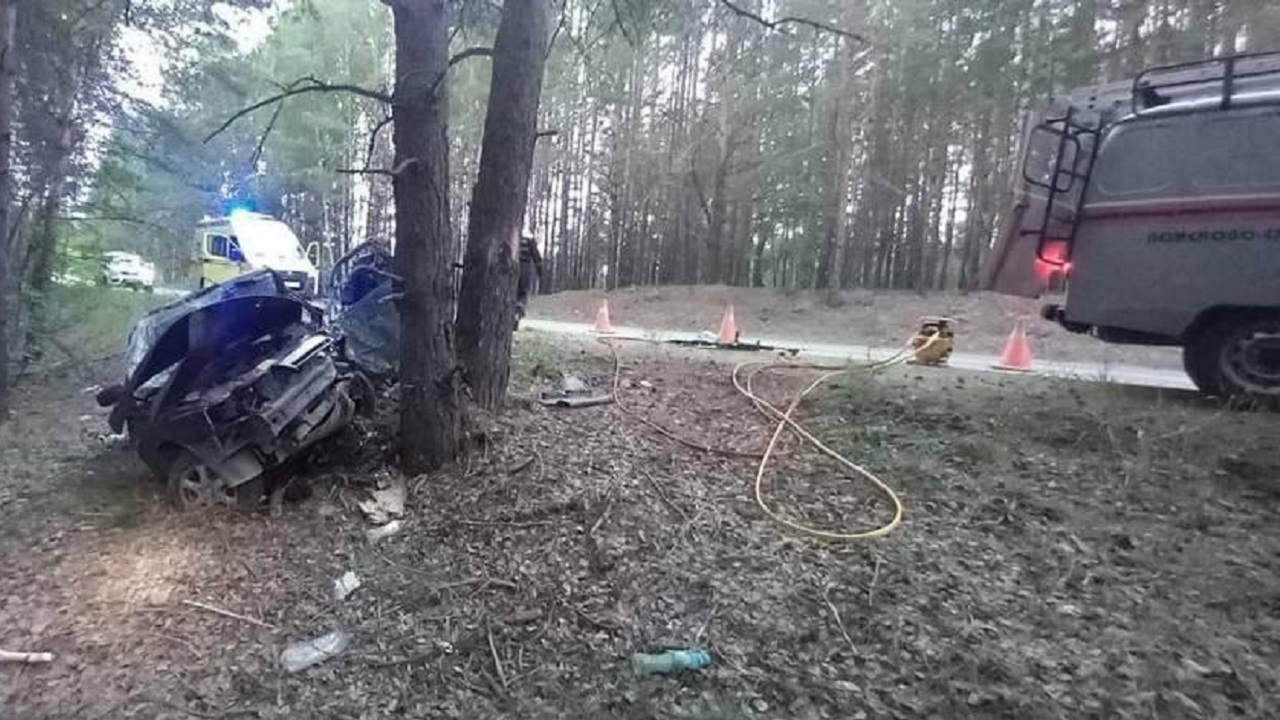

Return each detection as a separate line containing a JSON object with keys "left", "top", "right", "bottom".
{"left": 521, "top": 318, "right": 1196, "bottom": 389}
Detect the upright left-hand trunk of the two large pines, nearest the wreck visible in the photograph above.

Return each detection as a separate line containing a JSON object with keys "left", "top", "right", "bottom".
{"left": 392, "top": 0, "right": 461, "bottom": 474}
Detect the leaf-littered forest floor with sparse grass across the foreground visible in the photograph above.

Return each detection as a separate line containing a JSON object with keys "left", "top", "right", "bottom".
{"left": 0, "top": 341, "right": 1280, "bottom": 719}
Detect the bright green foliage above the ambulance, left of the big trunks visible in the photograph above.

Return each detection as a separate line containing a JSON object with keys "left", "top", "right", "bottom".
{"left": 73, "top": 0, "right": 389, "bottom": 282}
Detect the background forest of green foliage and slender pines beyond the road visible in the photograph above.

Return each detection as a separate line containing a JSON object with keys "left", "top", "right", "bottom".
{"left": 65, "top": 0, "right": 1280, "bottom": 290}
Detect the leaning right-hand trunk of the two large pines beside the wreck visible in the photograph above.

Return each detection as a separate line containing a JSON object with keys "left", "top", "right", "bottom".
{"left": 457, "top": 0, "right": 548, "bottom": 409}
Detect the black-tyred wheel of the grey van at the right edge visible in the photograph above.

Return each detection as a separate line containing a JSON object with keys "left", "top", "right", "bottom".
{"left": 1187, "top": 315, "right": 1280, "bottom": 402}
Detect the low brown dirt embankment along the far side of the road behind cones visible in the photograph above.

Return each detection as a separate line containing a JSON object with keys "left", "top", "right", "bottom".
{"left": 530, "top": 286, "right": 1181, "bottom": 368}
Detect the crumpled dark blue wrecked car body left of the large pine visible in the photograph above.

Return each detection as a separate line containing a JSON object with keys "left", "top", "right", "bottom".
{"left": 97, "top": 270, "right": 374, "bottom": 510}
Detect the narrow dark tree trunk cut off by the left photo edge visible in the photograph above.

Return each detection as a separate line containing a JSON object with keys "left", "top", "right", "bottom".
{"left": 0, "top": 0, "right": 18, "bottom": 421}
